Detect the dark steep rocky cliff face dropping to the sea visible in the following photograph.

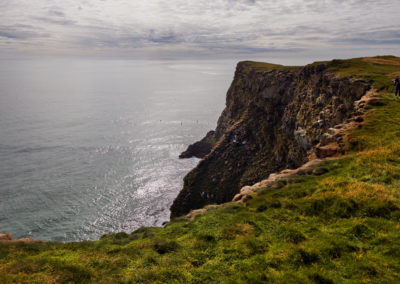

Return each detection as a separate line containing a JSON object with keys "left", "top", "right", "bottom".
{"left": 171, "top": 62, "right": 370, "bottom": 217}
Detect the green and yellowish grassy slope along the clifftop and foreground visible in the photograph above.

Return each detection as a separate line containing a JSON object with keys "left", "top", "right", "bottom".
{"left": 0, "top": 58, "right": 400, "bottom": 283}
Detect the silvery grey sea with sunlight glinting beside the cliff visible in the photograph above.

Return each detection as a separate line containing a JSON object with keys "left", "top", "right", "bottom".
{"left": 0, "top": 59, "right": 235, "bottom": 241}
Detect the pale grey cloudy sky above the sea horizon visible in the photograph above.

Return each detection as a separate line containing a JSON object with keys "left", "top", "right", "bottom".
{"left": 0, "top": 0, "right": 400, "bottom": 59}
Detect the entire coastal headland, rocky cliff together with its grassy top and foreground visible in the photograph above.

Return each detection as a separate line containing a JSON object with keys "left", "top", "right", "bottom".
{"left": 0, "top": 56, "right": 400, "bottom": 283}
